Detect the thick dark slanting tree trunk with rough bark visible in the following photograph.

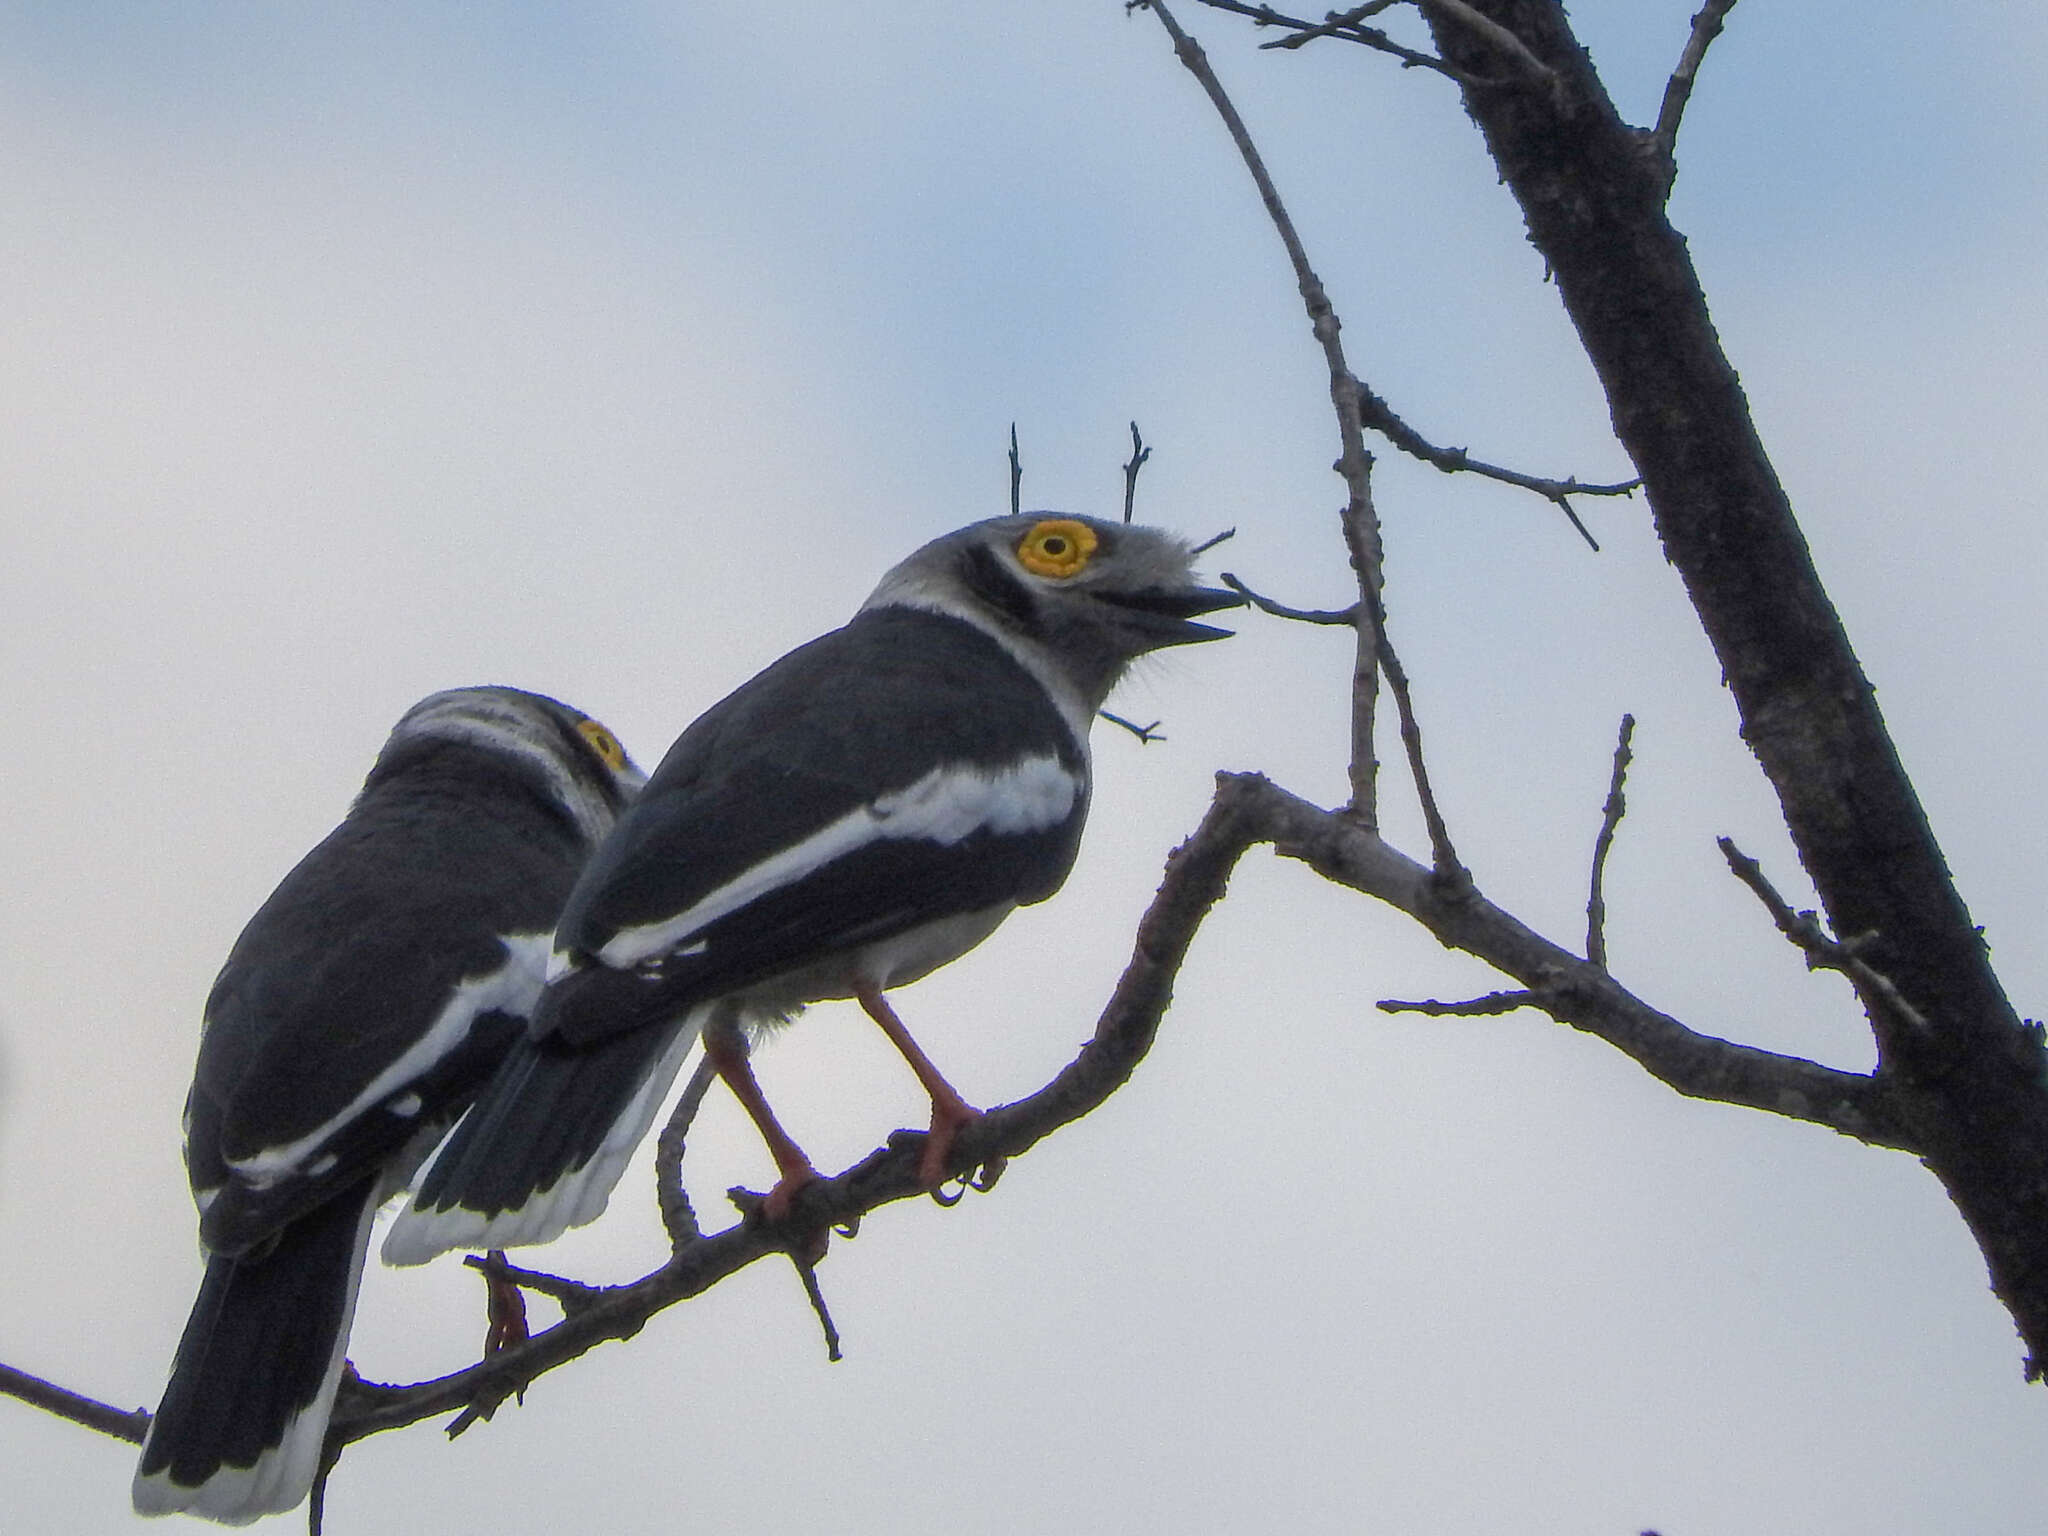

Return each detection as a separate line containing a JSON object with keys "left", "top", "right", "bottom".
{"left": 1425, "top": 0, "right": 2048, "bottom": 1376}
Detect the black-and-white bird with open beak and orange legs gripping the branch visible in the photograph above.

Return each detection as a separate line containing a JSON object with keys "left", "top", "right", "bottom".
{"left": 383, "top": 512, "right": 1241, "bottom": 1264}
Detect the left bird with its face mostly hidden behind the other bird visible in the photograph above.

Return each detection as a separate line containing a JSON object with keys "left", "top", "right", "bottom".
{"left": 135, "top": 688, "right": 645, "bottom": 1526}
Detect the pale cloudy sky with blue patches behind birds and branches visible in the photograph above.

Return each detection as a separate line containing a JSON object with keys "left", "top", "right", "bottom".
{"left": 0, "top": 0, "right": 2048, "bottom": 1536}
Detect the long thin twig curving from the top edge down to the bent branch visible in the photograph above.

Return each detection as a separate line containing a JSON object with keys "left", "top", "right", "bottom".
{"left": 1143, "top": 0, "right": 1384, "bottom": 825}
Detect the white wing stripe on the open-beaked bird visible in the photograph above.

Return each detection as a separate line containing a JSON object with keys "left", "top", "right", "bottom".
{"left": 593, "top": 758, "right": 1081, "bottom": 971}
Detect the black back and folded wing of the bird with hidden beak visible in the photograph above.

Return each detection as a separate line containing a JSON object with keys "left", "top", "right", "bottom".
{"left": 186, "top": 774, "right": 582, "bottom": 1253}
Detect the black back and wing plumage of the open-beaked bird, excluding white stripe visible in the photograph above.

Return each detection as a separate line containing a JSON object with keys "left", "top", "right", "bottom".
{"left": 532, "top": 608, "right": 1087, "bottom": 1042}
